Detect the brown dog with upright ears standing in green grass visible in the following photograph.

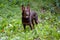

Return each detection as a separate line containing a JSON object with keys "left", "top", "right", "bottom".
{"left": 22, "top": 5, "right": 38, "bottom": 30}
